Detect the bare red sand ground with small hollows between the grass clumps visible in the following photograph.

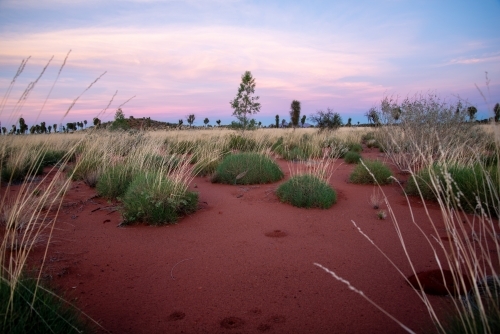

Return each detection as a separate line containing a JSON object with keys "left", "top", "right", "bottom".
{"left": 11, "top": 149, "right": 496, "bottom": 333}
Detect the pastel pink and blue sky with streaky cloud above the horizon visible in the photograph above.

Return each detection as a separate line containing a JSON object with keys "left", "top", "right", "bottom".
{"left": 0, "top": 0, "right": 500, "bottom": 126}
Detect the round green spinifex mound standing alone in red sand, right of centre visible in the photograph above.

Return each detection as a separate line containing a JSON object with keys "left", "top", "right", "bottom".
{"left": 276, "top": 174, "right": 337, "bottom": 209}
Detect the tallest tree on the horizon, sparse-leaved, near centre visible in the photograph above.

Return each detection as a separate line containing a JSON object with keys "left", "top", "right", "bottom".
{"left": 229, "top": 71, "right": 260, "bottom": 131}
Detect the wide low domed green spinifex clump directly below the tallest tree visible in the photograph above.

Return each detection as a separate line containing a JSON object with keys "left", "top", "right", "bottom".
{"left": 212, "top": 153, "right": 284, "bottom": 184}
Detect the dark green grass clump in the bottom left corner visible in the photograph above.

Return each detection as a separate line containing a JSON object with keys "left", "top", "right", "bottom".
{"left": 0, "top": 278, "right": 90, "bottom": 333}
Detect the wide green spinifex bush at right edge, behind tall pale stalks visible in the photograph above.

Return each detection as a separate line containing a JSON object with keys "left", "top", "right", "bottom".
{"left": 405, "top": 164, "right": 500, "bottom": 216}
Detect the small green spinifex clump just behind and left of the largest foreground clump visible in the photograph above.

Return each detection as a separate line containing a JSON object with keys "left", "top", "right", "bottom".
{"left": 96, "top": 164, "right": 137, "bottom": 199}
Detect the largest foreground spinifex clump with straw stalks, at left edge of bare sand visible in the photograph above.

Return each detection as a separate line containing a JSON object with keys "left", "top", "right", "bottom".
{"left": 122, "top": 171, "right": 198, "bottom": 225}
